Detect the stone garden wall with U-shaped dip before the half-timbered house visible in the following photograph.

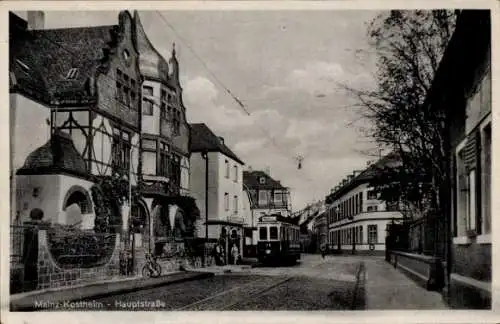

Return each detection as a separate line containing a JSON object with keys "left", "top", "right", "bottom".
{"left": 37, "top": 230, "right": 120, "bottom": 289}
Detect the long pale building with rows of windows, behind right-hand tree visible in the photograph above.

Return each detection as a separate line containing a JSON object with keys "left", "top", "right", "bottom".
{"left": 325, "top": 156, "right": 403, "bottom": 254}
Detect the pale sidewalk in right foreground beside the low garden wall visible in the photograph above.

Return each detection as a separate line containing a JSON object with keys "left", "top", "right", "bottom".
{"left": 364, "top": 257, "right": 448, "bottom": 310}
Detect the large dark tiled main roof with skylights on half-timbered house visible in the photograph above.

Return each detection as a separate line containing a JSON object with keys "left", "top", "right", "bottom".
{"left": 9, "top": 14, "right": 119, "bottom": 101}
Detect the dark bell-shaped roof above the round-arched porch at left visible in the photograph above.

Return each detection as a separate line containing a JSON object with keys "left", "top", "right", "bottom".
{"left": 17, "top": 132, "right": 89, "bottom": 177}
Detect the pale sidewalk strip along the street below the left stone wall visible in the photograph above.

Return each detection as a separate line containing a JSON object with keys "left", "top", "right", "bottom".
{"left": 10, "top": 271, "right": 214, "bottom": 311}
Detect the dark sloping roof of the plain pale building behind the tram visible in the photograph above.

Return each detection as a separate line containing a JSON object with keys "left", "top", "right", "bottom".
{"left": 190, "top": 123, "right": 245, "bottom": 165}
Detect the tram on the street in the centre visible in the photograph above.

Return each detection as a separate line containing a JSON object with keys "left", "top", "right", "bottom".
{"left": 257, "top": 214, "right": 300, "bottom": 263}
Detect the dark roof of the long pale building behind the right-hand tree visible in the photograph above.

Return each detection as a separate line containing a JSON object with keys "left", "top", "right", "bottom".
{"left": 327, "top": 152, "right": 401, "bottom": 200}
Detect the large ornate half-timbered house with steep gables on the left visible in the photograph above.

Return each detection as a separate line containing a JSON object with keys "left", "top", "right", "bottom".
{"left": 9, "top": 11, "right": 196, "bottom": 292}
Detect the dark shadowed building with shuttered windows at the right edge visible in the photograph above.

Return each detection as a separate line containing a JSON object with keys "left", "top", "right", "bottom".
{"left": 427, "top": 10, "right": 492, "bottom": 309}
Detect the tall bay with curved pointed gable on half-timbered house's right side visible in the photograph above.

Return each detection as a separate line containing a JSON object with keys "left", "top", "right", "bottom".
{"left": 134, "top": 12, "right": 190, "bottom": 195}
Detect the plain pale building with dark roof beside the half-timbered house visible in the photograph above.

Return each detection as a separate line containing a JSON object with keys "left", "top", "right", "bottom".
{"left": 190, "top": 124, "right": 244, "bottom": 262}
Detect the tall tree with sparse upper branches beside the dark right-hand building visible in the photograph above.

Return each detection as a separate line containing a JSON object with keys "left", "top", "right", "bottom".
{"left": 344, "top": 10, "right": 456, "bottom": 220}
